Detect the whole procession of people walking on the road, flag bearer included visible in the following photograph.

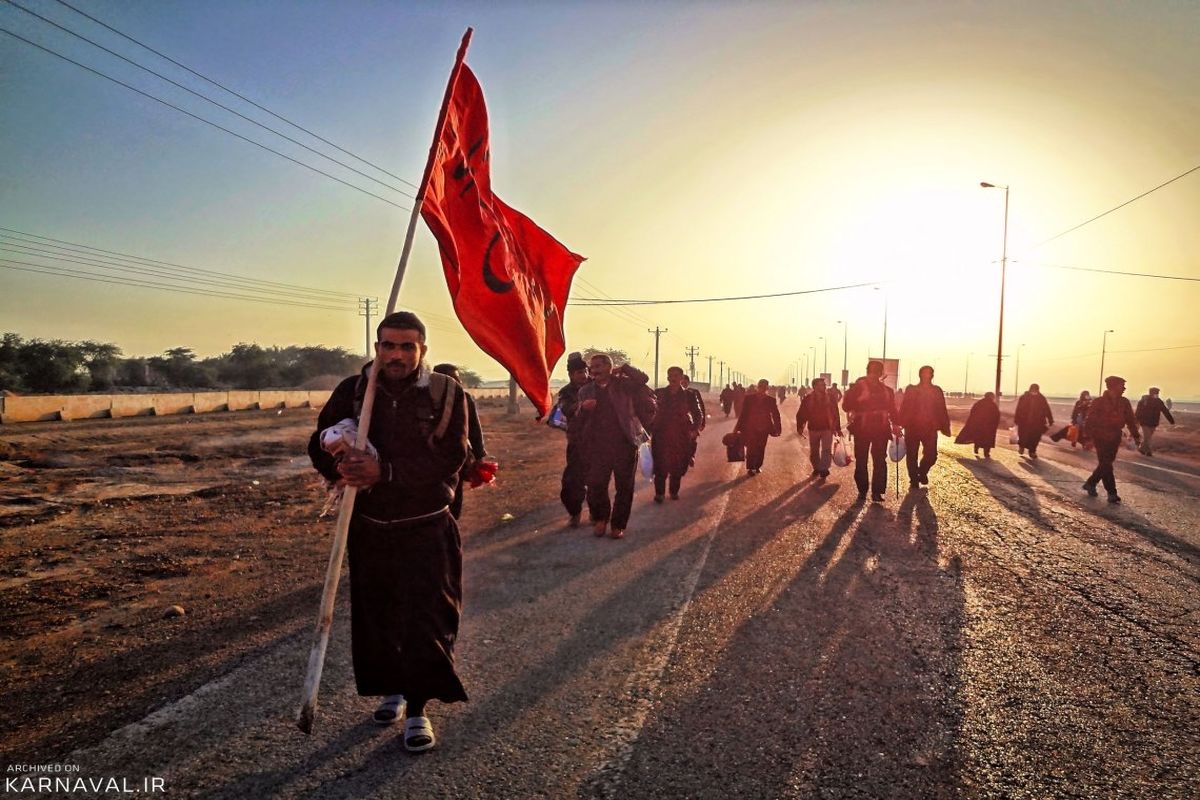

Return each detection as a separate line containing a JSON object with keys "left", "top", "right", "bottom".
{"left": 308, "top": 312, "right": 1175, "bottom": 752}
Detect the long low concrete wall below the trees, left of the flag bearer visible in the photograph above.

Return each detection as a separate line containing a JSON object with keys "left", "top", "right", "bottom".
{"left": 0, "top": 390, "right": 331, "bottom": 425}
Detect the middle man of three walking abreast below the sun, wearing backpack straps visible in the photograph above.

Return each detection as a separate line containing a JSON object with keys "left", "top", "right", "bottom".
{"left": 841, "top": 361, "right": 900, "bottom": 503}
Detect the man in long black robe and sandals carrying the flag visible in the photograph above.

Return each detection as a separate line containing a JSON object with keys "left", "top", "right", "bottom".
{"left": 308, "top": 312, "right": 467, "bottom": 751}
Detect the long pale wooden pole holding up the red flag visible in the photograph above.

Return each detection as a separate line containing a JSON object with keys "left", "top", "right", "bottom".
{"left": 296, "top": 28, "right": 473, "bottom": 734}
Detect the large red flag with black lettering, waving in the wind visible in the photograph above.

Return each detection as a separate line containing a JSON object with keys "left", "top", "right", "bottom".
{"left": 421, "top": 64, "right": 583, "bottom": 415}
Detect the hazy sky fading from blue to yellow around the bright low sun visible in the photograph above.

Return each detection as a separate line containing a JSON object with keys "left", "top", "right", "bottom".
{"left": 0, "top": 0, "right": 1200, "bottom": 399}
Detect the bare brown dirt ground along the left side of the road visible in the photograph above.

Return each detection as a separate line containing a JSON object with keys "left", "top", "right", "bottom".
{"left": 0, "top": 401, "right": 565, "bottom": 763}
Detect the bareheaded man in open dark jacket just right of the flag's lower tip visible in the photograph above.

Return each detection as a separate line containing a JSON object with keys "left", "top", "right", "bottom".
{"left": 578, "top": 353, "right": 653, "bottom": 539}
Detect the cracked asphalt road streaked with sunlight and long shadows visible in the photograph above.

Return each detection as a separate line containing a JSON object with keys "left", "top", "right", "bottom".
{"left": 39, "top": 407, "right": 1200, "bottom": 800}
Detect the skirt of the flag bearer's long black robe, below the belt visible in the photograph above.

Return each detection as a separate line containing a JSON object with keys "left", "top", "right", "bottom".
{"left": 347, "top": 513, "right": 467, "bottom": 703}
